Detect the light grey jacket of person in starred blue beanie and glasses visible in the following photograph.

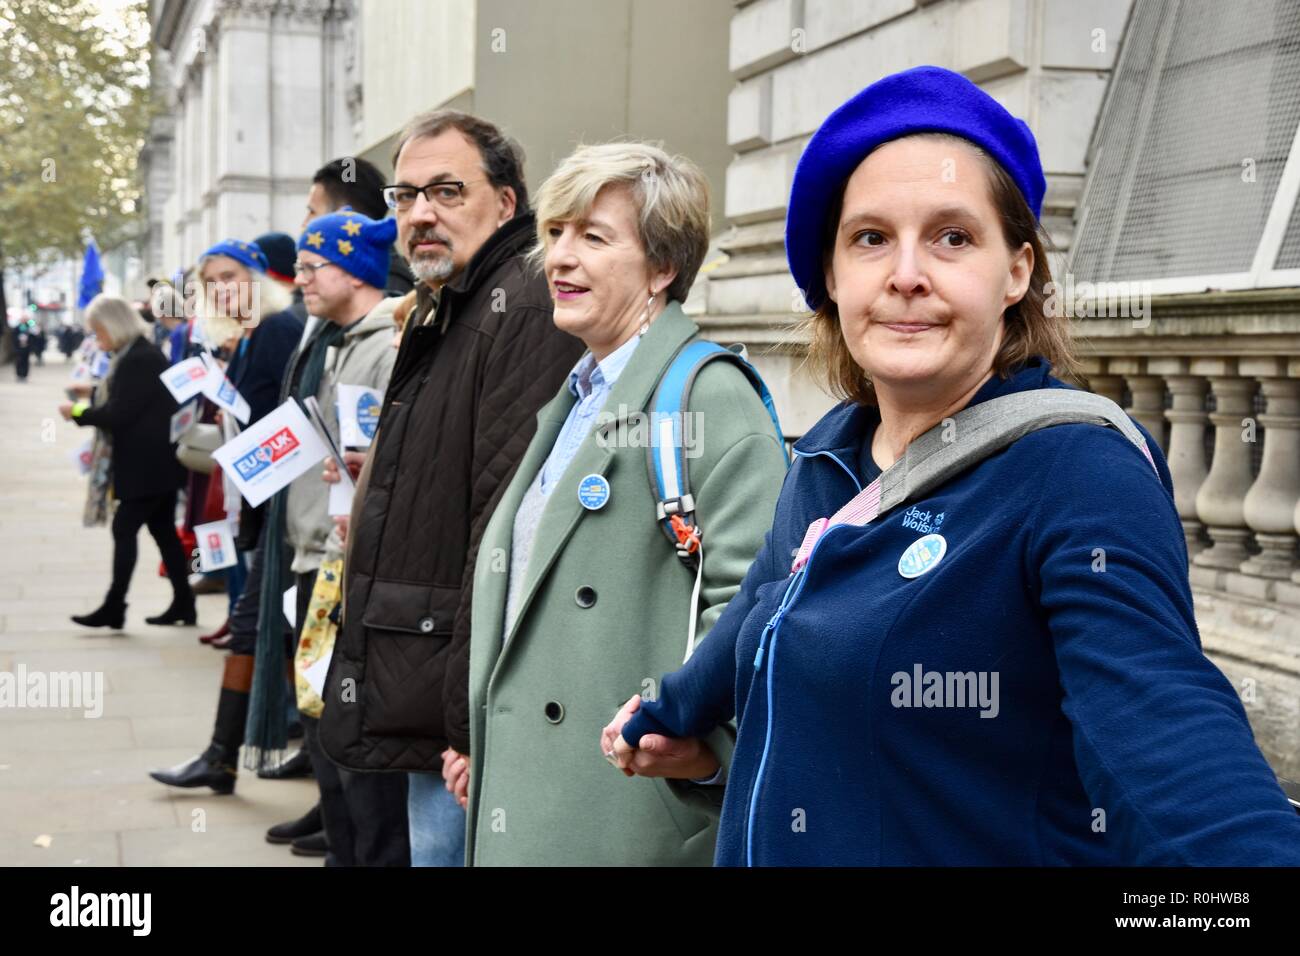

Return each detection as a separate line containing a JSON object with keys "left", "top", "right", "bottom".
{"left": 286, "top": 298, "right": 400, "bottom": 574}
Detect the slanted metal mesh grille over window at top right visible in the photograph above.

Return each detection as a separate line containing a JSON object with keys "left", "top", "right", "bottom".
{"left": 1070, "top": 0, "right": 1300, "bottom": 281}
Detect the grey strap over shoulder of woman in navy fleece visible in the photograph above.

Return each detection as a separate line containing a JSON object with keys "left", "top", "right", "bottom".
{"left": 880, "top": 389, "right": 1156, "bottom": 511}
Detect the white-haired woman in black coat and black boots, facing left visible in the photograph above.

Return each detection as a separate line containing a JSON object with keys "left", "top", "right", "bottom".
{"left": 59, "top": 295, "right": 196, "bottom": 628}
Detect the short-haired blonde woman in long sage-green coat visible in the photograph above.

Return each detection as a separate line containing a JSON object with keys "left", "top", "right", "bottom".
{"left": 443, "top": 143, "right": 785, "bottom": 866}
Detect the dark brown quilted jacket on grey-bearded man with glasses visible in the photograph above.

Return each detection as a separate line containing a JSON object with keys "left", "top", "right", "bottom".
{"left": 320, "top": 215, "right": 584, "bottom": 773}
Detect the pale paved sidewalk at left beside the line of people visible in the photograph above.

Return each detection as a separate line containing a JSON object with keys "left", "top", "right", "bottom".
{"left": 0, "top": 350, "right": 321, "bottom": 866}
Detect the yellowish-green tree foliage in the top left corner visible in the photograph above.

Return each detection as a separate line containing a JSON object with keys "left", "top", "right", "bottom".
{"left": 0, "top": 0, "right": 152, "bottom": 268}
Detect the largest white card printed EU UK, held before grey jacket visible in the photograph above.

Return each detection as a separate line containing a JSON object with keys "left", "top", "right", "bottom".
{"left": 212, "top": 398, "right": 329, "bottom": 507}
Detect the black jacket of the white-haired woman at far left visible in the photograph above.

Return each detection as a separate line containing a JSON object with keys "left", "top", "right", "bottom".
{"left": 73, "top": 336, "right": 185, "bottom": 501}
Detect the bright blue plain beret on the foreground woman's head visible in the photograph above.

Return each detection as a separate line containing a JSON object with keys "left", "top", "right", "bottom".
{"left": 785, "top": 66, "right": 1047, "bottom": 308}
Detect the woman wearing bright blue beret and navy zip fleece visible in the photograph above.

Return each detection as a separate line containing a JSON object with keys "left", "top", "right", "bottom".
{"left": 601, "top": 66, "right": 1300, "bottom": 865}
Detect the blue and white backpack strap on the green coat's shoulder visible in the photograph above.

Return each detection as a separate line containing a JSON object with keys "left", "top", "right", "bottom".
{"left": 646, "top": 339, "right": 789, "bottom": 566}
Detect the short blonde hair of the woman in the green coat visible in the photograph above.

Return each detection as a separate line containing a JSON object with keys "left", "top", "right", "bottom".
{"left": 530, "top": 142, "right": 710, "bottom": 302}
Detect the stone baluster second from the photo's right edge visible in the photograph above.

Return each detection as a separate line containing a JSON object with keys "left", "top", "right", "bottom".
{"left": 1192, "top": 359, "right": 1256, "bottom": 571}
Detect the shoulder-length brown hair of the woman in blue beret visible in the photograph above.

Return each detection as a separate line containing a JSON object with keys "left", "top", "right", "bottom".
{"left": 801, "top": 133, "right": 1082, "bottom": 405}
